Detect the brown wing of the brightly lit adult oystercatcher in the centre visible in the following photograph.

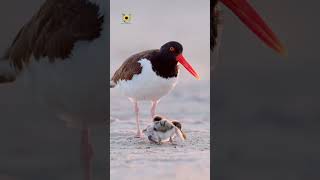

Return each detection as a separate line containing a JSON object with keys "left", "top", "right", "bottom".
{"left": 111, "top": 49, "right": 159, "bottom": 84}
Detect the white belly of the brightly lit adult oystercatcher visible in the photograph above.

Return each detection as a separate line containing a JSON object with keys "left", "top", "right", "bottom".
{"left": 117, "top": 59, "right": 178, "bottom": 101}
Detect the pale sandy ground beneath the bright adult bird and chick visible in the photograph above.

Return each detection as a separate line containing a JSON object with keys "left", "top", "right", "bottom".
{"left": 110, "top": 81, "right": 210, "bottom": 180}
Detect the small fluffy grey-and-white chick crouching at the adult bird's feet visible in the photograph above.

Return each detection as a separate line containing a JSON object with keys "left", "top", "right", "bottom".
{"left": 143, "top": 116, "right": 186, "bottom": 144}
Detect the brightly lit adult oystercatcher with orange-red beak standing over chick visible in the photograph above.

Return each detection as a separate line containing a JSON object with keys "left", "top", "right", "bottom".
{"left": 110, "top": 41, "right": 200, "bottom": 137}
